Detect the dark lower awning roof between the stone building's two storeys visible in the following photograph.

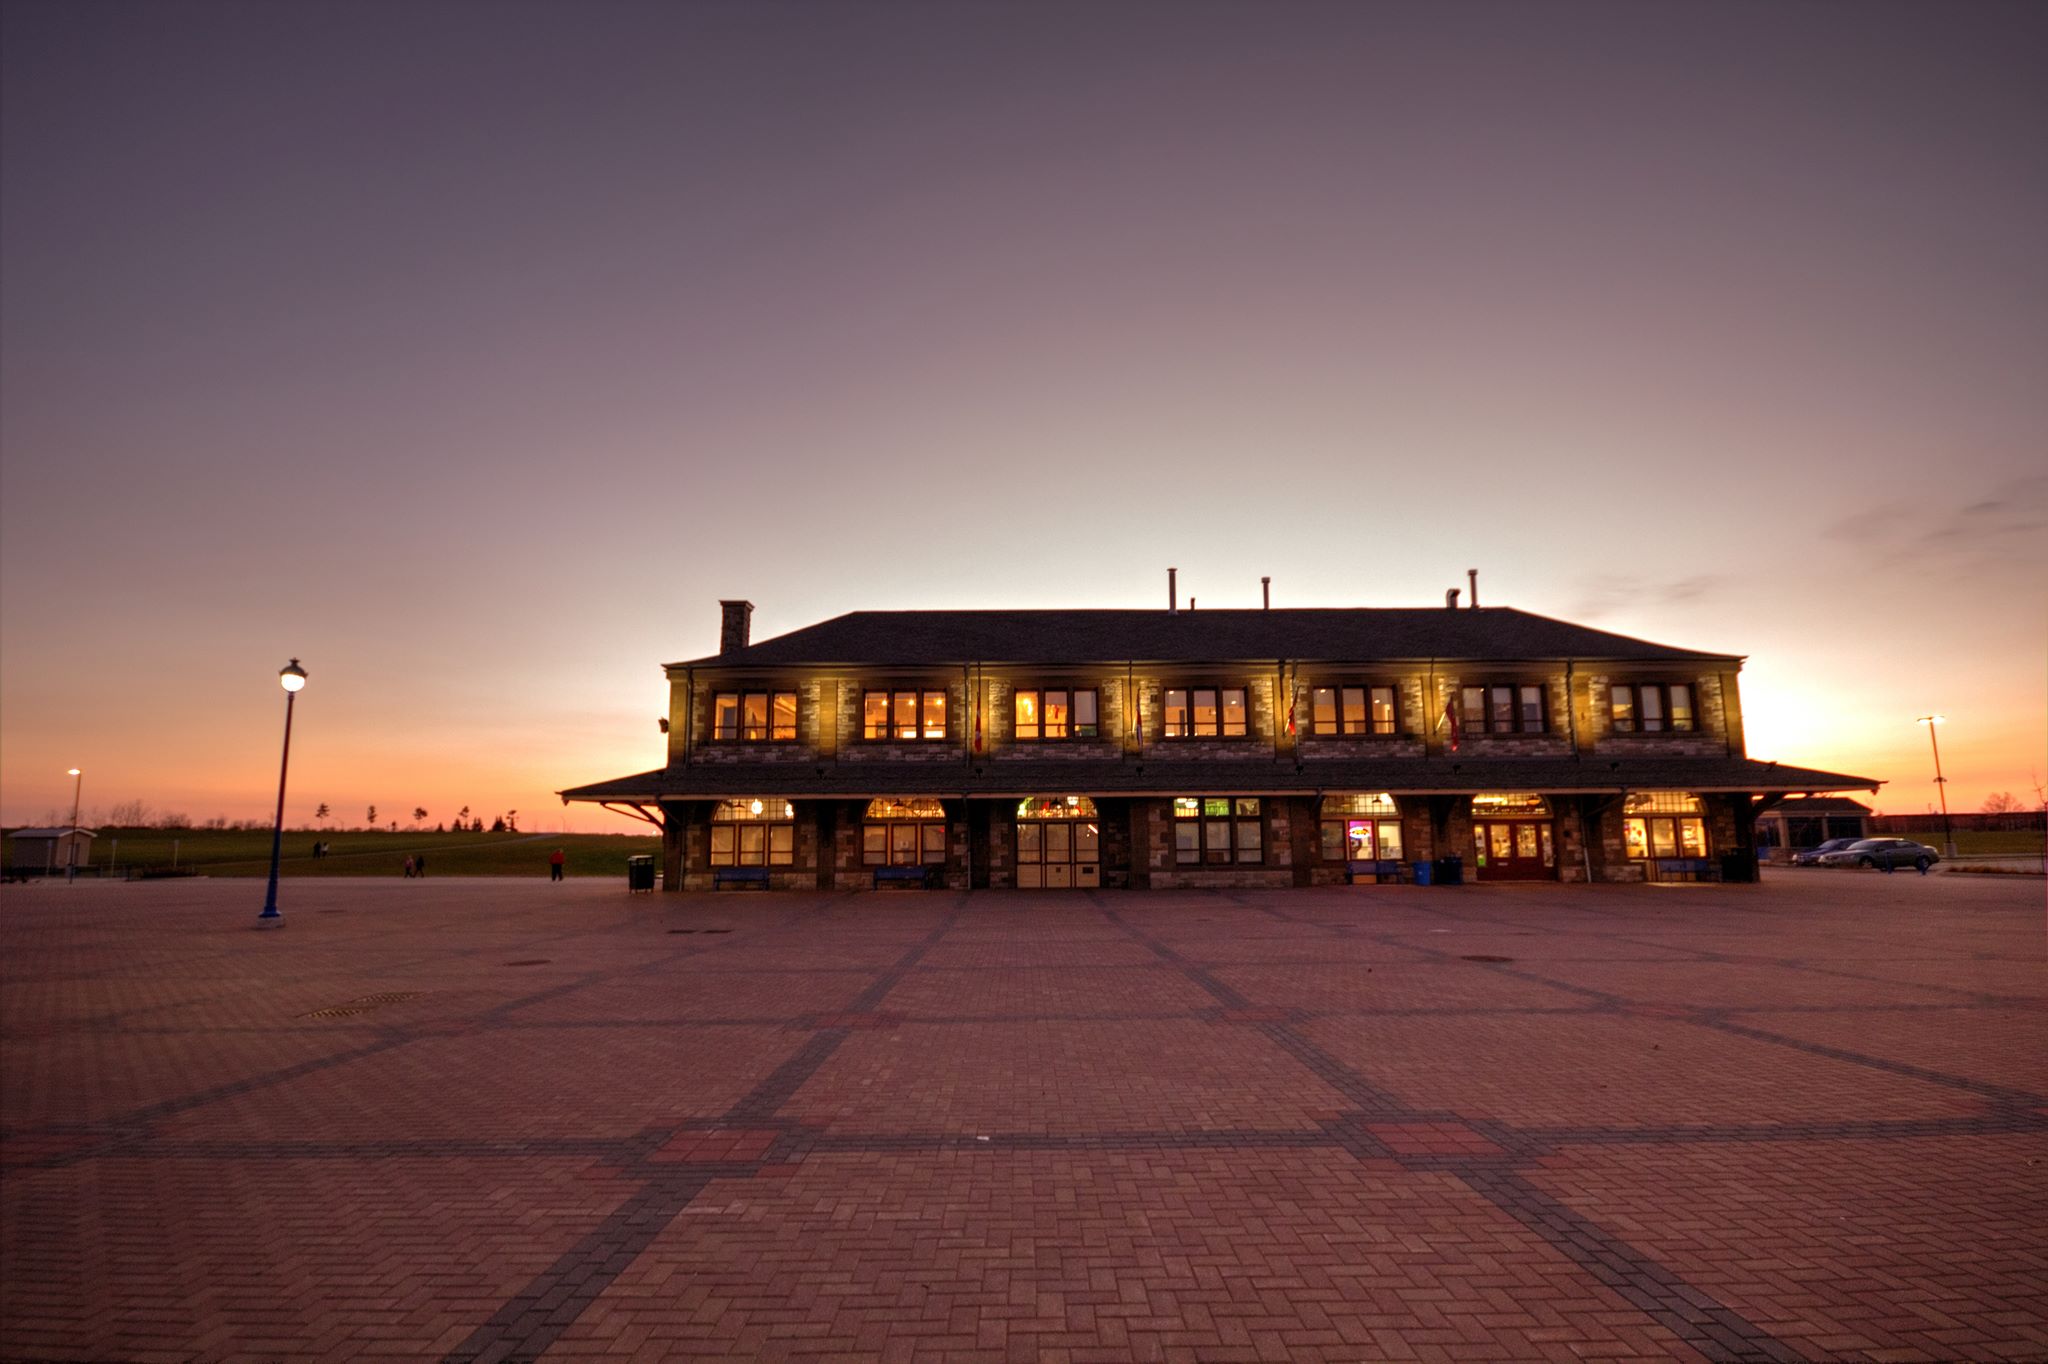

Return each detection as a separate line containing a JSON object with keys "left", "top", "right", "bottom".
{"left": 559, "top": 756, "right": 1880, "bottom": 803}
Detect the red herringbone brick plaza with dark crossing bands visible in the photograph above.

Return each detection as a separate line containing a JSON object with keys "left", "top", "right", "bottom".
{"left": 0, "top": 872, "right": 2048, "bottom": 1362}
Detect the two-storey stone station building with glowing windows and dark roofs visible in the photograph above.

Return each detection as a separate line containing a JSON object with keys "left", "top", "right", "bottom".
{"left": 561, "top": 594, "right": 1878, "bottom": 891}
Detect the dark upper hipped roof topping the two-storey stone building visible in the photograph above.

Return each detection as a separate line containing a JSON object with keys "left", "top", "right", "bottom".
{"left": 670, "top": 606, "right": 1741, "bottom": 668}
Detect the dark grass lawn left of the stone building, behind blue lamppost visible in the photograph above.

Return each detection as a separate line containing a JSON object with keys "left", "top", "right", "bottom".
{"left": 10, "top": 829, "right": 662, "bottom": 877}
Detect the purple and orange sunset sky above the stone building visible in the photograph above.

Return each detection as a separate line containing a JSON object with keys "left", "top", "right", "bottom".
{"left": 0, "top": 0, "right": 2048, "bottom": 829}
